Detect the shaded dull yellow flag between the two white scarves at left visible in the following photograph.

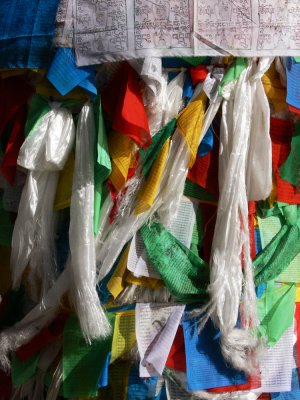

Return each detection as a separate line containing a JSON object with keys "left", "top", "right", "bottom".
{"left": 54, "top": 152, "right": 75, "bottom": 210}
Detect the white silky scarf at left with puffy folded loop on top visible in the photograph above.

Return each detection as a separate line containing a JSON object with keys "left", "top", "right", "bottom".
{"left": 11, "top": 103, "right": 75, "bottom": 294}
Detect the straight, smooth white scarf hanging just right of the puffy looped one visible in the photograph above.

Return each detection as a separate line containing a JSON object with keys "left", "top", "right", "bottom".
{"left": 69, "top": 103, "right": 110, "bottom": 342}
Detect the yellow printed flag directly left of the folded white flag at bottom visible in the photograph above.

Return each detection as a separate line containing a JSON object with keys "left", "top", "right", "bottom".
{"left": 110, "top": 310, "right": 136, "bottom": 363}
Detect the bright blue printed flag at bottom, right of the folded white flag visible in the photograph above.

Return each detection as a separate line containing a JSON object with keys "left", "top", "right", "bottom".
{"left": 182, "top": 318, "right": 247, "bottom": 391}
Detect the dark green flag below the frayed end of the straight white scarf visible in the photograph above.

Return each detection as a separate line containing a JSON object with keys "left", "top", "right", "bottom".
{"left": 63, "top": 313, "right": 115, "bottom": 398}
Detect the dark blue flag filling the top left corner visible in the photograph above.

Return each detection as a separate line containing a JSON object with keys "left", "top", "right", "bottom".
{"left": 0, "top": 0, "right": 59, "bottom": 68}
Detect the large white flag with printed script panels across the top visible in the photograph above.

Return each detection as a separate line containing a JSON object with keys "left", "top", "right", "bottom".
{"left": 74, "top": 0, "right": 300, "bottom": 65}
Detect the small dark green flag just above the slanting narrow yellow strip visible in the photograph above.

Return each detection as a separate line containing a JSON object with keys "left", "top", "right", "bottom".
{"left": 139, "top": 118, "right": 176, "bottom": 176}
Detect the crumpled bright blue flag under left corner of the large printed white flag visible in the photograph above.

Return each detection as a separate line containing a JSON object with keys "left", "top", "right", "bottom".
{"left": 47, "top": 47, "right": 97, "bottom": 96}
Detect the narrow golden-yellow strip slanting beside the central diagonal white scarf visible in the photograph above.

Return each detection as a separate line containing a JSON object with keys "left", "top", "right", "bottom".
{"left": 134, "top": 138, "right": 171, "bottom": 214}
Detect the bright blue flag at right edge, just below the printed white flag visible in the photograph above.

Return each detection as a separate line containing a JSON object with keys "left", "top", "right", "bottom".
{"left": 286, "top": 57, "right": 300, "bottom": 108}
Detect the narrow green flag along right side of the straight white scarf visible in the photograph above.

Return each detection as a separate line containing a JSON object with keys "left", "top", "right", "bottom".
{"left": 94, "top": 97, "right": 111, "bottom": 235}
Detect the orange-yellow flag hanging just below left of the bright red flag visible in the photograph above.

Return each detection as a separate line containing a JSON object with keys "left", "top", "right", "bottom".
{"left": 108, "top": 131, "right": 134, "bottom": 191}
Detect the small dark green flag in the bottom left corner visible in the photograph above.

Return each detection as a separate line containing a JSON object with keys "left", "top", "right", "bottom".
{"left": 11, "top": 353, "right": 40, "bottom": 388}
